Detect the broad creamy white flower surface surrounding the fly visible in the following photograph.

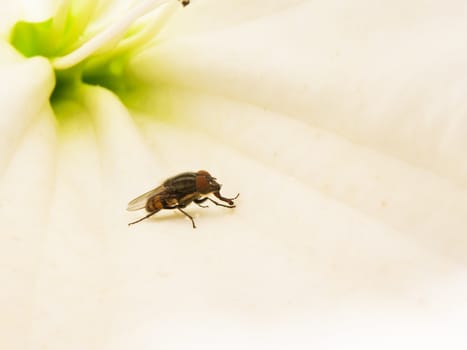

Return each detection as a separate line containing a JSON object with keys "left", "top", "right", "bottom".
{"left": 0, "top": 0, "right": 467, "bottom": 350}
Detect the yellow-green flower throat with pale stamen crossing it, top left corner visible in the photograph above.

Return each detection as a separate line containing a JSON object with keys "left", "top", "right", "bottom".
{"left": 10, "top": 0, "right": 188, "bottom": 108}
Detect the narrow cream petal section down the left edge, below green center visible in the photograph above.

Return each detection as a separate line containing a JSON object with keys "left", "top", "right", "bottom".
{"left": 0, "top": 42, "right": 55, "bottom": 349}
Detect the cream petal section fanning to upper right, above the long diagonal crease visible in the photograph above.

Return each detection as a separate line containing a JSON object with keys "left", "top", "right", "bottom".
{"left": 134, "top": 0, "right": 467, "bottom": 184}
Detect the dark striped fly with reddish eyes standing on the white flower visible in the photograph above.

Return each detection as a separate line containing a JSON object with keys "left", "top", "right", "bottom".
{"left": 127, "top": 170, "right": 240, "bottom": 228}
